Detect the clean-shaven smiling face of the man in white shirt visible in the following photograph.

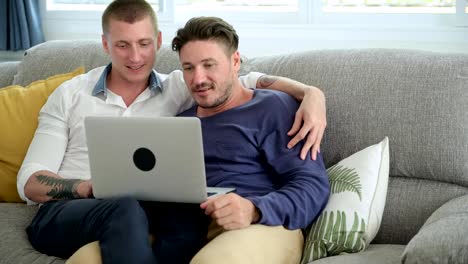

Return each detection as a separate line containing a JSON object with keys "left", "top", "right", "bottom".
{"left": 102, "top": 16, "right": 161, "bottom": 87}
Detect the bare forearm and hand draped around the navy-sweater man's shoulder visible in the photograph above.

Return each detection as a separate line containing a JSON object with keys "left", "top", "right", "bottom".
{"left": 257, "top": 75, "right": 327, "bottom": 160}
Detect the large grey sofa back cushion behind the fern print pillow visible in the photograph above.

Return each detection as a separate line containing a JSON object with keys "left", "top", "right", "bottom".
{"left": 241, "top": 49, "right": 468, "bottom": 243}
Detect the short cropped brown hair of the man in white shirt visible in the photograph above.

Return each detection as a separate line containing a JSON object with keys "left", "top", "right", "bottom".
{"left": 101, "top": 0, "right": 159, "bottom": 35}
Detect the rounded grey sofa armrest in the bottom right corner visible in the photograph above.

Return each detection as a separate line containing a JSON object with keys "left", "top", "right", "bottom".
{"left": 402, "top": 195, "right": 468, "bottom": 264}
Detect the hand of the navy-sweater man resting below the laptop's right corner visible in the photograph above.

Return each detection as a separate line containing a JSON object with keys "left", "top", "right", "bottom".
{"left": 200, "top": 193, "right": 260, "bottom": 230}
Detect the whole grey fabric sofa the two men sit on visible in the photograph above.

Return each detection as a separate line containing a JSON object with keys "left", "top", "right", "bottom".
{"left": 0, "top": 40, "right": 468, "bottom": 264}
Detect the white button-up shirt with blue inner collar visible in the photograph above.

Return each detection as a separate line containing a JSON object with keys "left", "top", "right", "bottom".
{"left": 17, "top": 64, "right": 262, "bottom": 204}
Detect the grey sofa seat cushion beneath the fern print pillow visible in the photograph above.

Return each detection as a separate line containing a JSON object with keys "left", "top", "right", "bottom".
{"left": 309, "top": 244, "right": 405, "bottom": 264}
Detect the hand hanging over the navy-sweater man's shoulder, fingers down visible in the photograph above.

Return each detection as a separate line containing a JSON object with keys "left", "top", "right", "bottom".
{"left": 288, "top": 86, "right": 327, "bottom": 160}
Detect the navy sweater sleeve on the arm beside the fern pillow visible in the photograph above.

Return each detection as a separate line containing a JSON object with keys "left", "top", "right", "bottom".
{"left": 247, "top": 96, "right": 330, "bottom": 229}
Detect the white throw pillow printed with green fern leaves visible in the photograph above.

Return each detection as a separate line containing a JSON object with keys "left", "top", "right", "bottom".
{"left": 301, "top": 137, "right": 389, "bottom": 264}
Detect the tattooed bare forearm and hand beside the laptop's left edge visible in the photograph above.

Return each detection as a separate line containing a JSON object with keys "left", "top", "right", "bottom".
{"left": 24, "top": 170, "right": 93, "bottom": 203}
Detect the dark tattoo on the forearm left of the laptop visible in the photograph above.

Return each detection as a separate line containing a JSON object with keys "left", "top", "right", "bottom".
{"left": 37, "top": 175, "right": 82, "bottom": 200}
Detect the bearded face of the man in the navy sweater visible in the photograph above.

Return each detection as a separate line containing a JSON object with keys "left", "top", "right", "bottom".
{"left": 179, "top": 40, "right": 240, "bottom": 108}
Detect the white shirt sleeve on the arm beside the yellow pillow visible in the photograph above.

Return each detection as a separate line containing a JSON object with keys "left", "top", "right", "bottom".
{"left": 17, "top": 84, "right": 68, "bottom": 205}
